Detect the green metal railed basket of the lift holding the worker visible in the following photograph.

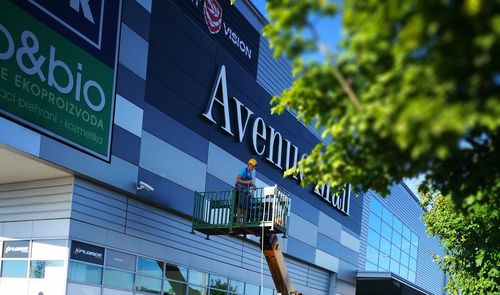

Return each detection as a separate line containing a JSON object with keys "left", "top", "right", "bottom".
{"left": 193, "top": 186, "right": 290, "bottom": 235}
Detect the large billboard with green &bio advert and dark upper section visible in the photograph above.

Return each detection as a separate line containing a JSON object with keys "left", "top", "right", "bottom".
{"left": 0, "top": 0, "right": 121, "bottom": 160}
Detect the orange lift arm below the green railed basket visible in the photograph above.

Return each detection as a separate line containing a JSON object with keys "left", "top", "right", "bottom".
{"left": 261, "top": 233, "right": 302, "bottom": 295}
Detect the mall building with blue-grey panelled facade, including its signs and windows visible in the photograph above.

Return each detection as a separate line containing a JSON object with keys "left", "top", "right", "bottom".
{"left": 0, "top": 0, "right": 445, "bottom": 295}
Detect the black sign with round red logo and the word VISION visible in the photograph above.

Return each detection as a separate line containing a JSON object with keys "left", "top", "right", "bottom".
{"left": 169, "top": 0, "right": 260, "bottom": 78}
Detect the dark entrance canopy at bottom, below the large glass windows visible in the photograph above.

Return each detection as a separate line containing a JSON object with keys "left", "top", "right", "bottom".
{"left": 356, "top": 271, "right": 432, "bottom": 295}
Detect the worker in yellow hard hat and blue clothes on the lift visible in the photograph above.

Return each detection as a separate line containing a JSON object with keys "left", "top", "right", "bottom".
{"left": 234, "top": 159, "right": 257, "bottom": 223}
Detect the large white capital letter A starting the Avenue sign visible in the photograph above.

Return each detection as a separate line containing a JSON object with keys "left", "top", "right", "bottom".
{"left": 203, "top": 66, "right": 234, "bottom": 136}
